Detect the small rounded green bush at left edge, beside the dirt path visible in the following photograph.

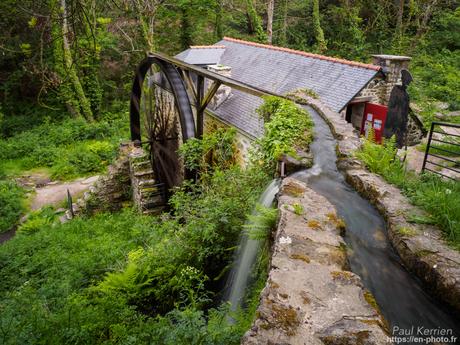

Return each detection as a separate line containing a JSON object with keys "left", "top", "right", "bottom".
{"left": 0, "top": 180, "right": 25, "bottom": 233}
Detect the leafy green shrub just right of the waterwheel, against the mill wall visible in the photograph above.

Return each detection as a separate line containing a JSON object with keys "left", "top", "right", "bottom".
{"left": 179, "top": 128, "right": 236, "bottom": 173}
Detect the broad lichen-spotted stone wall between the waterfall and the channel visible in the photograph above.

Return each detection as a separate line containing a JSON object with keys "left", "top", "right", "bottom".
{"left": 242, "top": 178, "right": 387, "bottom": 345}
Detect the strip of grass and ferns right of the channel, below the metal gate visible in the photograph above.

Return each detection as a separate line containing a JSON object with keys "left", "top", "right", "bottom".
{"left": 357, "top": 134, "right": 460, "bottom": 250}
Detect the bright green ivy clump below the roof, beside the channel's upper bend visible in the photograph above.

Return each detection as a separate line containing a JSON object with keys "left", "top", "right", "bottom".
{"left": 256, "top": 96, "right": 313, "bottom": 169}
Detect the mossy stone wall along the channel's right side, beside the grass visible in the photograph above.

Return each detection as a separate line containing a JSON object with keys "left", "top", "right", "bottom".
{"left": 298, "top": 99, "right": 460, "bottom": 315}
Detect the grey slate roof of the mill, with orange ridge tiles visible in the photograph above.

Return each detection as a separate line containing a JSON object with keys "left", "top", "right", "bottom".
{"left": 176, "top": 37, "right": 380, "bottom": 137}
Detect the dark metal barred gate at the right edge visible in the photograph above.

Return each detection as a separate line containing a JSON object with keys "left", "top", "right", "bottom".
{"left": 422, "top": 121, "right": 460, "bottom": 181}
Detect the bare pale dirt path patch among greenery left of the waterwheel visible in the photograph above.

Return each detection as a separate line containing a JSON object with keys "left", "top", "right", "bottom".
{"left": 31, "top": 176, "right": 99, "bottom": 210}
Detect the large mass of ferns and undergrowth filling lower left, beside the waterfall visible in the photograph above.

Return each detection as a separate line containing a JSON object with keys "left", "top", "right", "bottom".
{"left": 0, "top": 122, "right": 280, "bottom": 344}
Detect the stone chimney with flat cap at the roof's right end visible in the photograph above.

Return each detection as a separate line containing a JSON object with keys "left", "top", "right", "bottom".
{"left": 372, "top": 55, "right": 411, "bottom": 104}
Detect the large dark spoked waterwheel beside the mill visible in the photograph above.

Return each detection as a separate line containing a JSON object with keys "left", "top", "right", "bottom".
{"left": 130, "top": 56, "right": 196, "bottom": 193}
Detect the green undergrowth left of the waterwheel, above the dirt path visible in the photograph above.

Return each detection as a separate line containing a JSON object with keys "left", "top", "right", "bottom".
{"left": 0, "top": 114, "right": 129, "bottom": 180}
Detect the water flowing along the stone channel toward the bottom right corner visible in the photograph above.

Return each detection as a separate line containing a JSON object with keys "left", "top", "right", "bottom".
{"left": 293, "top": 107, "right": 460, "bottom": 341}
